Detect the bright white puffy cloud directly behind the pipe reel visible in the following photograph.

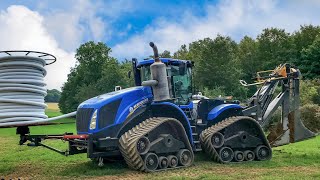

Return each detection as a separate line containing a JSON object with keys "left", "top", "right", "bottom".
{"left": 0, "top": 6, "right": 75, "bottom": 89}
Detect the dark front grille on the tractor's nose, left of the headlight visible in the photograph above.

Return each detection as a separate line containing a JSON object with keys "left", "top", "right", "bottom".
{"left": 77, "top": 108, "right": 94, "bottom": 132}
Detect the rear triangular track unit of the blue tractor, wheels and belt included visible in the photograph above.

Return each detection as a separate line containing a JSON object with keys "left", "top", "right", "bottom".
{"left": 200, "top": 116, "right": 272, "bottom": 163}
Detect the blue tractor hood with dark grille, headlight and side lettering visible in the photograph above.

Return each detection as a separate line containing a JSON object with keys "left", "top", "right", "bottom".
{"left": 77, "top": 86, "right": 153, "bottom": 134}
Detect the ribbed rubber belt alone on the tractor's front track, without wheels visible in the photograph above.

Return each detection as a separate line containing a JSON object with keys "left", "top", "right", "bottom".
{"left": 119, "top": 117, "right": 193, "bottom": 171}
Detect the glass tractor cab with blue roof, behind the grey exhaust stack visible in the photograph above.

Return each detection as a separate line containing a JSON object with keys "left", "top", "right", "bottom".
{"left": 132, "top": 58, "right": 192, "bottom": 105}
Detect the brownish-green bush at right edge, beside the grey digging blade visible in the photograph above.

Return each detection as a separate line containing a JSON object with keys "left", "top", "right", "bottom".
{"left": 300, "top": 104, "right": 320, "bottom": 132}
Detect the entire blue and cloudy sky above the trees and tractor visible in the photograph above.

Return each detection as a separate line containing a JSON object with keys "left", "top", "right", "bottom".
{"left": 0, "top": 0, "right": 320, "bottom": 89}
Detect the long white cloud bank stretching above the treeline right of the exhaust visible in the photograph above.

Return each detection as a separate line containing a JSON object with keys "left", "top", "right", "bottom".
{"left": 113, "top": 0, "right": 320, "bottom": 59}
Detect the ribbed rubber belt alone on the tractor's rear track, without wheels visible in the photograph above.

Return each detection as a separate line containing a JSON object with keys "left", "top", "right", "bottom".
{"left": 200, "top": 116, "right": 271, "bottom": 163}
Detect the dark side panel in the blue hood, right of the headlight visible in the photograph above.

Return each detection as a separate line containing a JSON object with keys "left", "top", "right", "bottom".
{"left": 98, "top": 99, "right": 122, "bottom": 129}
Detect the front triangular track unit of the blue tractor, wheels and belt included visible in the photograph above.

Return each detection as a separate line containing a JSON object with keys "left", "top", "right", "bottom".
{"left": 119, "top": 117, "right": 194, "bottom": 172}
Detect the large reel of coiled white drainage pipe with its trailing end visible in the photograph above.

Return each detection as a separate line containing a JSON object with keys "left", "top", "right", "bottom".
{"left": 0, "top": 51, "right": 76, "bottom": 127}
